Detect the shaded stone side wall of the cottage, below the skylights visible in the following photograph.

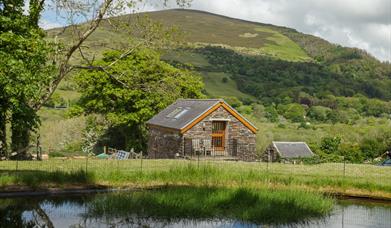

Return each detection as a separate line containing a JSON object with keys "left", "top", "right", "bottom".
{"left": 148, "top": 126, "right": 183, "bottom": 158}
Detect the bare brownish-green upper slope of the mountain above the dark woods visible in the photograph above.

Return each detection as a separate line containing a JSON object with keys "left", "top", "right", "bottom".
{"left": 141, "top": 10, "right": 311, "bottom": 61}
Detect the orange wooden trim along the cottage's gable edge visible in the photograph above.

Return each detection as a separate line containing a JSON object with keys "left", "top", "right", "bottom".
{"left": 181, "top": 101, "right": 257, "bottom": 134}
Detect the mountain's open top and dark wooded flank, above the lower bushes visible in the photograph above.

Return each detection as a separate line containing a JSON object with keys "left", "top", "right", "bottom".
{"left": 49, "top": 10, "right": 391, "bottom": 106}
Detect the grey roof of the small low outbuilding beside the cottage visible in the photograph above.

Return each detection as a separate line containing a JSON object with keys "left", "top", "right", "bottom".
{"left": 273, "top": 142, "right": 314, "bottom": 158}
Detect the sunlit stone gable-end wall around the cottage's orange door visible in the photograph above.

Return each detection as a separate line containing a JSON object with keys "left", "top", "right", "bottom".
{"left": 181, "top": 107, "right": 257, "bottom": 161}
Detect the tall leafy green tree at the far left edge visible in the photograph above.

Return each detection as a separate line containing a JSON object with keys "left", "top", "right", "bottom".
{"left": 0, "top": 0, "right": 54, "bottom": 157}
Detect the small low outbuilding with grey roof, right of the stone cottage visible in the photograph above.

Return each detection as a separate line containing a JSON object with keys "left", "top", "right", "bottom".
{"left": 262, "top": 142, "right": 314, "bottom": 162}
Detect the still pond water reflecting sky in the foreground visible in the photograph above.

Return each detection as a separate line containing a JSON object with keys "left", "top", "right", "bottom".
{"left": 0, "top": 193, "right": 391, "bottom": 227}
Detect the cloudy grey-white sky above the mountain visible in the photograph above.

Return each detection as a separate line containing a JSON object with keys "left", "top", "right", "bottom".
{"left": 41, "top": 0, "right": 391, "bottom": 61}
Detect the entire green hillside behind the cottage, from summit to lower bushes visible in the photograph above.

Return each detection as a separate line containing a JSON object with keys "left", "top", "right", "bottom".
{"left": 41, "top": 10, "right": 391, "bottom": 161}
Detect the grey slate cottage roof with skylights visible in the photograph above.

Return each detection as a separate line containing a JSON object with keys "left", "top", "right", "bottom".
{"left": 147, "top": 99, "right": 221, "bottom": 130}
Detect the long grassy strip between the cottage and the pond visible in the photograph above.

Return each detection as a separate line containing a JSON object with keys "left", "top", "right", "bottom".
{"left": 0, "top": 159, "right": 391, "bottom": 199}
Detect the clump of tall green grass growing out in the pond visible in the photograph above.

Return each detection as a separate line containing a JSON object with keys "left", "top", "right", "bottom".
{"left": 87, "top": 186, "right": 333, "bottom": 224}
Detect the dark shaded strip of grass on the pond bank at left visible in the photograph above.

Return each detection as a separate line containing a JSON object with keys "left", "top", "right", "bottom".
{"left": 0, "top": 170, "right": 95, "bottom": 188}
